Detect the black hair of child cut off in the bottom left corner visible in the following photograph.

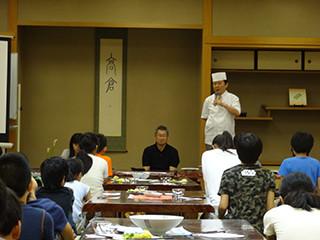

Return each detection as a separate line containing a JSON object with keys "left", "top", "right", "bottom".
{"left": 0, "top": 181, "right": 22, "bottom": 236}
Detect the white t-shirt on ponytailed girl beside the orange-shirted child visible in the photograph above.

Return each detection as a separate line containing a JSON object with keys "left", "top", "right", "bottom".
{"left": 81, "top": 154, "right": 108, "bottom": 196}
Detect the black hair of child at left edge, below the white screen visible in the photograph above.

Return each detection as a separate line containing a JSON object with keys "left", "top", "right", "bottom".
{"left": 0, "top": 153, "right": 31, "bottom": 198}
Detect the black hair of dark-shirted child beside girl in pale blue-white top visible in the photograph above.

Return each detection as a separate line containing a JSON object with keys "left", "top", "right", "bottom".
{"left": 40, "top": 157, "right": 69, "bottom": 190}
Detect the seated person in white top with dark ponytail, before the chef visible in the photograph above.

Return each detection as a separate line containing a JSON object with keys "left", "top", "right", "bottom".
{"left": 201, "top": 131, "right": 241, "bottom": 206}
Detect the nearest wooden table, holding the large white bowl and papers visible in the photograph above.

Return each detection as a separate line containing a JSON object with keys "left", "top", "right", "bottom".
{"left": 81, "top": 218, "right": 266, "bottom": 240}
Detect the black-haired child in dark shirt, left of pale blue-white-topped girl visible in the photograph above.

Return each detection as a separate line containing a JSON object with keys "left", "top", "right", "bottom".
{"left": 36, "top": 157, "right": 75, "bottom": 229}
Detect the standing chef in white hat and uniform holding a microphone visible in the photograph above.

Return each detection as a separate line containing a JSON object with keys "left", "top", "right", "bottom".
{"left": 201, "top": 72, "right": 241, "bottom": 150}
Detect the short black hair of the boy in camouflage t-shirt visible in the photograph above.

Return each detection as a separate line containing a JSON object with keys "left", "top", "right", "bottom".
{"left": 235, "top": 133, "right": 262, "bottom": 165}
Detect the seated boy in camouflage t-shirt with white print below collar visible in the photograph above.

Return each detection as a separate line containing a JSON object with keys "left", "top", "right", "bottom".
{"left": 219, "top": 133, "right": 275, "bottom": 232}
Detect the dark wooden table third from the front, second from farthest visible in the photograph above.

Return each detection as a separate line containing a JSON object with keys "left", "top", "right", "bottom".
{"left": 103, "top": 178, "right": 201, "bottom": 191}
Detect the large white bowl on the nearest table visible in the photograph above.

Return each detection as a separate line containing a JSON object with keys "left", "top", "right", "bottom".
{"left": 130, "top": 215, "right": 183, "bottom": 235}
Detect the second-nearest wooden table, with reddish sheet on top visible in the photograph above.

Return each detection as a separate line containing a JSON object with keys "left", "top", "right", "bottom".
{"left": 83, "top": 191, "right": 214, "bottom": 218}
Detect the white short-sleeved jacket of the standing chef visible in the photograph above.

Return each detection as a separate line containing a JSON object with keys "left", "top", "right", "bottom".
{"left": 201, "top": 91, "right": 241, "bottom": 145}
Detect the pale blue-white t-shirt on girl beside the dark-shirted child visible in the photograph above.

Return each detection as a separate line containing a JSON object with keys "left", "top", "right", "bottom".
{"left": 64, "top": 180, "right": 90, "bottom": 224}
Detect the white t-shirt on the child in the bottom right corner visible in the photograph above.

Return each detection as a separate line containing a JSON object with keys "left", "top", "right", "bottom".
{"left": 263, "top": 205, "right": 320, "bottom": 240}
